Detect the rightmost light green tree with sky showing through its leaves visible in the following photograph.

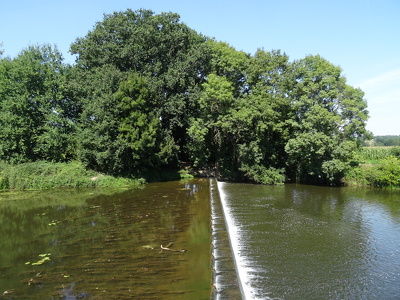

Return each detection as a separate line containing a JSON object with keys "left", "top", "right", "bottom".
{"left": 285, "top": 55, "right": 369, "bottom": 184}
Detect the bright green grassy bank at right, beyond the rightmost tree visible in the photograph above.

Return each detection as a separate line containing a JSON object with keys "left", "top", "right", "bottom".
{"left": 346, "top": 147, "right": 400, "bottom": 188}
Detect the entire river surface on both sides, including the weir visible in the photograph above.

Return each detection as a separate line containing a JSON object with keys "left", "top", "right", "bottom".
{"left": 0, "top": 179, "right": 400, "bottom": 300}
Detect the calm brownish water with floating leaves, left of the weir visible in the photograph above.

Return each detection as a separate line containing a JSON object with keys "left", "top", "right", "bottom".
{"left": 0, "top": 180, "right": 211, "bottom": 299}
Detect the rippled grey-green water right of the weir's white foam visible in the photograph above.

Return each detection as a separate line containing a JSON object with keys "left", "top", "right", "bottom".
{"left": 221, "top": 183, "right": 400, "bottom": 299}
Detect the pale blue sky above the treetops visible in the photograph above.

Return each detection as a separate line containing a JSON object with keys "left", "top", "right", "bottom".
{"left": 0, "top": 0, "right": 400, "bottom": 135}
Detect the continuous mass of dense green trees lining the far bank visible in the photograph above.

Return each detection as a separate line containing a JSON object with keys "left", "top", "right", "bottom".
{"left": 0, "top": 10, "right": 369, "bottom": 184}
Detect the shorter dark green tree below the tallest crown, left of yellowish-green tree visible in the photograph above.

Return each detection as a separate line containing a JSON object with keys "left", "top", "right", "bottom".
{"left": 70, "top": 65, "right": 129, "bottom": 174}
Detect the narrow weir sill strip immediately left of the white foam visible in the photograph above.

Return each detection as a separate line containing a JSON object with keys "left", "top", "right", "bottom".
{"left": 210, "top": 178, "right": 244, "bottom": 300}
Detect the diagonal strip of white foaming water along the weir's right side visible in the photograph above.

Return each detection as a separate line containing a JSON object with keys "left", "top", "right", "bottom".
{"left": 217, "top": 182, "right": 256, "bottom": 299}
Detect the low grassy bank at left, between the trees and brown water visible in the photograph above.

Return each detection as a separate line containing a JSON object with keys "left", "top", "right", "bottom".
{"left": 0, "top": 161, "right": 145, "bottom": 190}
